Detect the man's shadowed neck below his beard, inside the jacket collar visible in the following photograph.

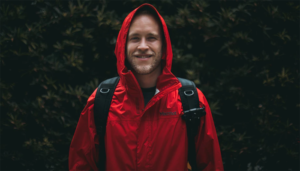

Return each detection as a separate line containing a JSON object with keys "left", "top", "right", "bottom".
{"left": 133, "top": 67, "right": 161, "bottom": 88}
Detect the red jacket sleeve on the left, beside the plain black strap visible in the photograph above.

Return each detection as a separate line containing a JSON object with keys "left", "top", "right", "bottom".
{"left": 69, "top": 90, "right": 99, "bottom": 171}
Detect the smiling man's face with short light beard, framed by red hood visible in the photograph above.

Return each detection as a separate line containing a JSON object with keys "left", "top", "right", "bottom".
{"left": 127, "top": 14, "right": 162, "bottom": 75}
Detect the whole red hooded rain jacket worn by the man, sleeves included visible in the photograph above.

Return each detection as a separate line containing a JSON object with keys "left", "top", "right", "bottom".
{"left": 69, "top": 4, "right": 223, "bottom": 171}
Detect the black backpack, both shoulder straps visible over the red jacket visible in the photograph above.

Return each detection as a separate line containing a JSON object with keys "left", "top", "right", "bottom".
{"left": 94, "top": 77, "right": 205, "bottom": 170}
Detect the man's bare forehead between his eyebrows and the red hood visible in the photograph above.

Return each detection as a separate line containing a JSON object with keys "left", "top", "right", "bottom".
{"left": 129, "top": 14, "right": 161, "bottom": 35}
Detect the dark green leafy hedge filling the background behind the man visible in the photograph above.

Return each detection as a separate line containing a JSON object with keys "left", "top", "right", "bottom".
{"left": 0, "top": 0, "right": 300, "bottom": 171}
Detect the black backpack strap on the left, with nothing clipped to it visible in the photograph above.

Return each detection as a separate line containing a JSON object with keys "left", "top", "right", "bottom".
{"left": 94, "top": 77, "right": 120, "bottom": 170}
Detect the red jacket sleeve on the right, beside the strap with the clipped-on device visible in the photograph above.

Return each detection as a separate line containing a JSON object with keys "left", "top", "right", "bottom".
{"left": 195, "top": 90, "right": 224, "bottom": 171}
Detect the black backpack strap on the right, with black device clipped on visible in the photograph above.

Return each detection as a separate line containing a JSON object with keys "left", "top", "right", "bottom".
{"left": 177, "top": 77, "right": 205, "bottom": 170}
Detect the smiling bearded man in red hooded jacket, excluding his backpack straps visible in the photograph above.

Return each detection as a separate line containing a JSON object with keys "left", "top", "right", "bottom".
{"left": 69, "top": 4, "right": 223, "bottom": 171}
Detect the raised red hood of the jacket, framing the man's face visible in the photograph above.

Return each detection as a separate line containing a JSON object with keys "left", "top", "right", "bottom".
{"left": 115, "top": 3, "right": 180, "bottom": 94}
